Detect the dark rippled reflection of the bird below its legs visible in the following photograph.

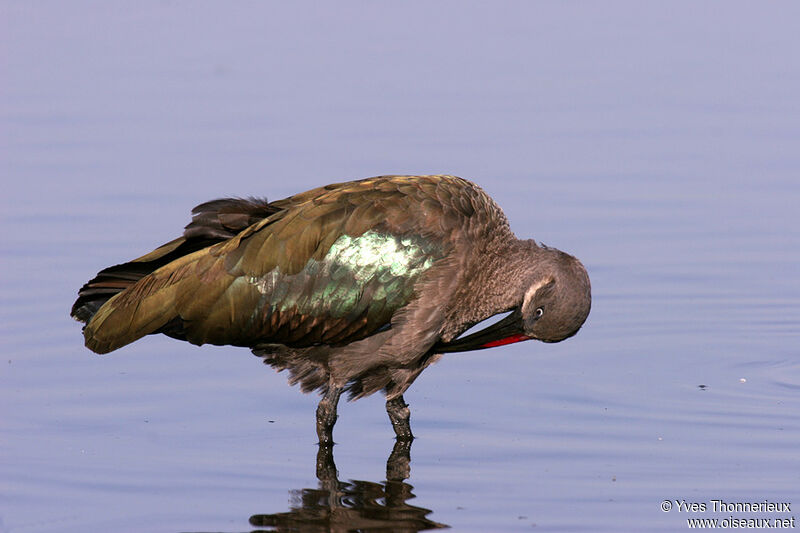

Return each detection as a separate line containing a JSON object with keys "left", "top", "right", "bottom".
{"left": 250, "top": 441, "right": 449, "bottom": 533}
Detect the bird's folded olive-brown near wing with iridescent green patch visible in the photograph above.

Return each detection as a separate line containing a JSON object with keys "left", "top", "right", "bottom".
{"left": 84, "top": 176, "right": 485, "bottom": 353}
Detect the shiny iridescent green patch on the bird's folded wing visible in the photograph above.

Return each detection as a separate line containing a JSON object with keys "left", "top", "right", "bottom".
{"left": 248, "top": 231, "right": 440, "bottom": 344}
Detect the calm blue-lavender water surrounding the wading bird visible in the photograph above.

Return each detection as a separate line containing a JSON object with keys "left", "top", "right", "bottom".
{"left": 0, "top": 2, "right": 800, "bottom": 532}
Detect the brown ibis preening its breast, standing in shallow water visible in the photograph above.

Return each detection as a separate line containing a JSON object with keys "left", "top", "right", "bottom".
{"left": 71, "top": 175, "right": 591, "bottom": 445}
